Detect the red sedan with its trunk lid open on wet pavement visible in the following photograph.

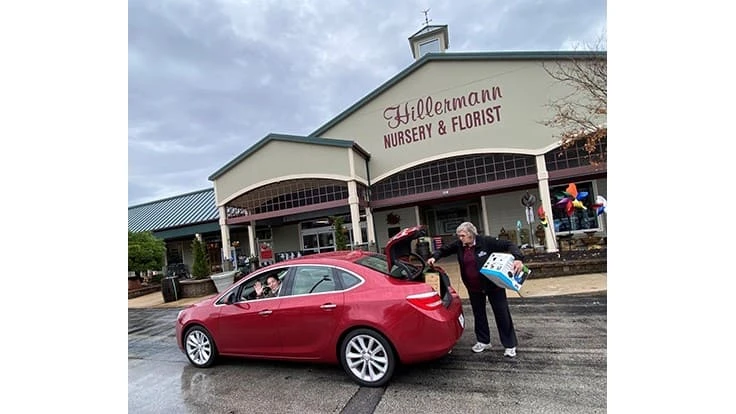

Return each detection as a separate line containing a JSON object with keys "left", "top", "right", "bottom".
{"left": 176, "top": 227, "right": 465, "bottom": 387}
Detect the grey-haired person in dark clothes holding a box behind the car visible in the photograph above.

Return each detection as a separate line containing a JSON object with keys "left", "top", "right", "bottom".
{"left": 427, "top": 221, "right": 524, "bottom": 358}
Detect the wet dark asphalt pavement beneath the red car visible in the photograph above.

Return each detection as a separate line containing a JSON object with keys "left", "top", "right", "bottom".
{"left": 128, "top": 292, "right": 607, "bottom": 414}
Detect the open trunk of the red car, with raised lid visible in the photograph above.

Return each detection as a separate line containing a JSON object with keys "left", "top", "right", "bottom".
{"left": 385, "top": 226, "right": 452, "bottom": 307}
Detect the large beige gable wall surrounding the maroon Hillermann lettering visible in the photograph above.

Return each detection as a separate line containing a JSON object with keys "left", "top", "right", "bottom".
{"left": 322, "top": 61, "right": 584, "bottom": 182}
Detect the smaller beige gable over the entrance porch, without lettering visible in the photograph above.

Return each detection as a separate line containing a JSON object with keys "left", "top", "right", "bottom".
{"left": 214, "top": 140, "right": 367, "bottom": 205}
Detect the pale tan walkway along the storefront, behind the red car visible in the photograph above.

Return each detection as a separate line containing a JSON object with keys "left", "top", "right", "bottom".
{"left": 128, "top": 260, "right": 608, "bottom": 308}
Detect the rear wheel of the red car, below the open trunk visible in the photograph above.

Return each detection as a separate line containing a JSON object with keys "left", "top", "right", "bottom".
{"left": 340, "top": 329, "right": 397, "bottom": 387}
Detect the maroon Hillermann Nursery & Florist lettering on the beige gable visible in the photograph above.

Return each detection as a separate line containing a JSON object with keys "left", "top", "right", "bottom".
{"left": 383, "top": 86, "right": 503, "bottom": 149}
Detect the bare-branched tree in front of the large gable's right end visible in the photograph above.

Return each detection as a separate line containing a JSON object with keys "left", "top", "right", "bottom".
{"left": 543, "top": 36, "right": 608, "bottom": 162}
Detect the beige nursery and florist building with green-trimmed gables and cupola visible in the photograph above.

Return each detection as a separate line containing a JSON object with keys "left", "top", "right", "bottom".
{"left": 128, "top": 26, "right": 607, "bottom": 274}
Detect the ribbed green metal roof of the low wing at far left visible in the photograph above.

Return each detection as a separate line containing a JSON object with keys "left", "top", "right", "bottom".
{"left": 128, "top": 188, "right": 220, "bottom": 232}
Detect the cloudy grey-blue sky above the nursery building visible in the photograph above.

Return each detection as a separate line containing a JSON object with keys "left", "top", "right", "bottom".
{"left": 128, "top": 0, "right": 607, "bottom": 206}
